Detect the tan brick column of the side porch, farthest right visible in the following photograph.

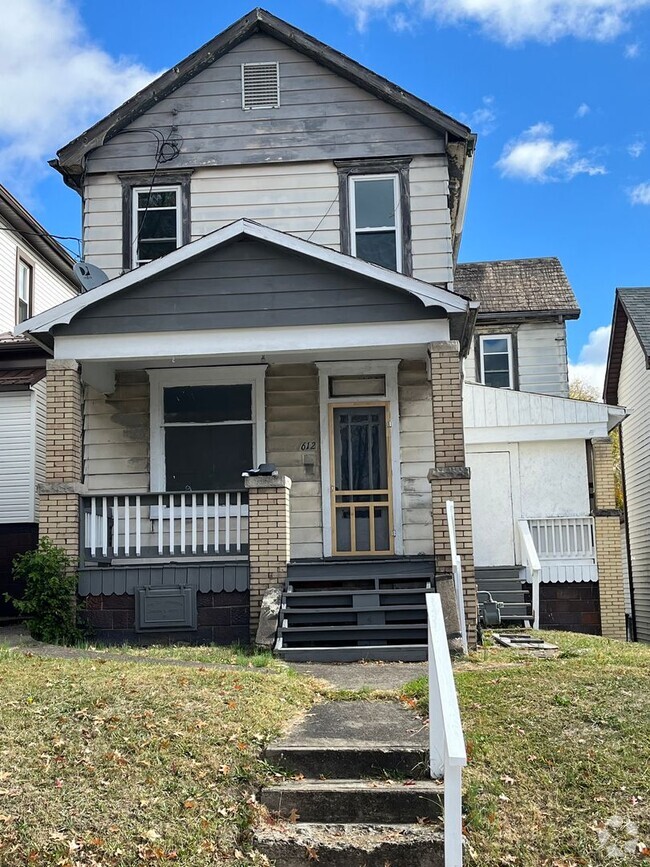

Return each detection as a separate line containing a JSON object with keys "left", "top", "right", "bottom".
{"left": 591, "top": 437, "right": 626, "bottom": 641}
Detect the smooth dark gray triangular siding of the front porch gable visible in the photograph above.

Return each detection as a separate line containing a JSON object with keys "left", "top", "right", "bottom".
{"left": 61, "top": 240, "right": 445, "bottom": 334}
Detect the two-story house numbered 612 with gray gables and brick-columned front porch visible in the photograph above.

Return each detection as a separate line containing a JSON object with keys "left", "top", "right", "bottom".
{"left": 13, "top": 10, "right": 620, "bottom": 658}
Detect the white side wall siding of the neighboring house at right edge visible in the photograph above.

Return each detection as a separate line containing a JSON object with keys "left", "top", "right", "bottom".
{"left": 618, "top": 325, "right": 650, "bottom": 641}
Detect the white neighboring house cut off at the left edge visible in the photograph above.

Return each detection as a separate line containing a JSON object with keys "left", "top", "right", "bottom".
{"left": 0, "top": 186, "right": 77, "bottom": 619}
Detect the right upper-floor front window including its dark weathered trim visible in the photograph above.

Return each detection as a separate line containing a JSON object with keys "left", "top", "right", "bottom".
{"left": 335, "top": 157, "right": 413, "bottom": 275}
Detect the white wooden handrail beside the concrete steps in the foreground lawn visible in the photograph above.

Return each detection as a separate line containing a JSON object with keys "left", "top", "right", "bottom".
{"left": 426, "top": 593, "right": 467, "bottom": 867}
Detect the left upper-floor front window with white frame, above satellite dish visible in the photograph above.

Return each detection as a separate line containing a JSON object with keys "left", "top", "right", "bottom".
{"left": 132, "top": 186, "right": 182, "bottom": 267}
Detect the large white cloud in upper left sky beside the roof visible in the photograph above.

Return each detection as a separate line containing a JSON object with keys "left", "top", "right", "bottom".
{"left": 0, "top": 0, "right": 159, "bottom": 192}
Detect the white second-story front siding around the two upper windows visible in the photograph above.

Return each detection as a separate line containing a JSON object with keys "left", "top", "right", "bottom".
{"left": 83, "top": 156, "right": 452, "bottom": 283}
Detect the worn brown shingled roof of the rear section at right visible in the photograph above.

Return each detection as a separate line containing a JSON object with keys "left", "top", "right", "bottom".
{"left": 454, "top": 256, "right": 580, "bottom": 319}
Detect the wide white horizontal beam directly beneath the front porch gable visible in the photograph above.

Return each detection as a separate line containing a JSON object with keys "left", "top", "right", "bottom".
{"left": 54, "top": 318, "right": 449, "bottom": 361}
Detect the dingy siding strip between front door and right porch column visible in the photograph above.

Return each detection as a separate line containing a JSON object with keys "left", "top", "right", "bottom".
{"left": 397, "top": 361, "right": 434, "bottom": 556}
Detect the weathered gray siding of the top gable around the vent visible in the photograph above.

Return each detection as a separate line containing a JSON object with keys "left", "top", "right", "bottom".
{"left": 87, "top": 33, "right": 444, "bottom": 172}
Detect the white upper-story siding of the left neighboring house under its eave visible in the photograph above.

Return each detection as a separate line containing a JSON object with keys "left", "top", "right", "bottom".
{"left": 0, "top": 220, "right": 76, "bottom": 332}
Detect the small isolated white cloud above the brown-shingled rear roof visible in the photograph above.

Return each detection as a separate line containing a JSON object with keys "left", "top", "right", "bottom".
{"left": 496, "top": 123, "right": 606, "bottom": 183}
